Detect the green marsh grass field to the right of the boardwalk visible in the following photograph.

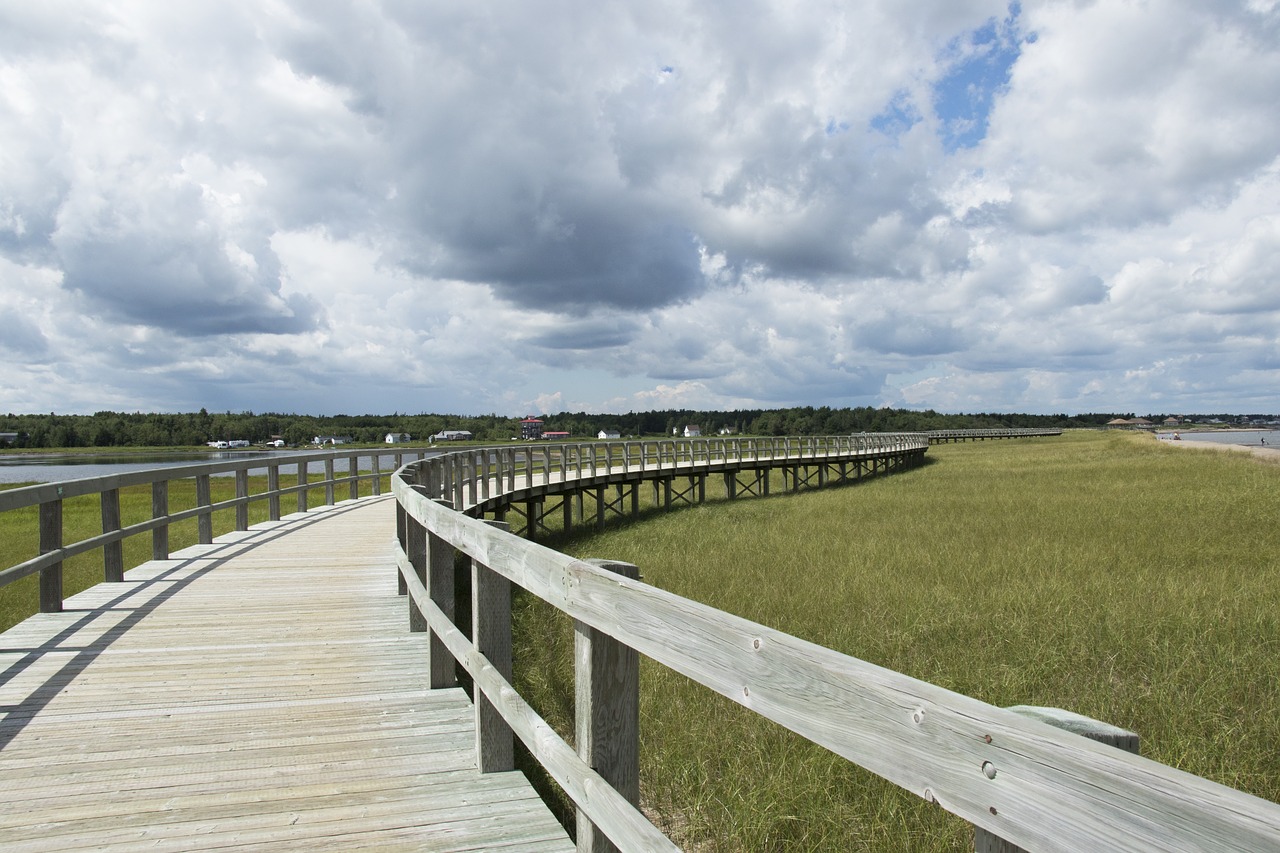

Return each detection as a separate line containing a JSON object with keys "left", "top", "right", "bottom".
{"left": 517, "top": 433, "right": 1280, "bottom": 850}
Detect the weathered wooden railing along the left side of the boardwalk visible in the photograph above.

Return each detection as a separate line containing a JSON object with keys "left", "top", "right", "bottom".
{"left": 0, "top": 450, "right": 434, "bottom": 612}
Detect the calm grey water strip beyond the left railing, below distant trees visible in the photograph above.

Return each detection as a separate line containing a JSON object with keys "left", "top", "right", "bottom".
{"left": 0, "top": 451, "right": 435, "bottom": 483}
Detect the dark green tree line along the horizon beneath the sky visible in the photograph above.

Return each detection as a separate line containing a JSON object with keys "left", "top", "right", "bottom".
{"left": 0, "top": 406, "right": 1133, "bottom": 448}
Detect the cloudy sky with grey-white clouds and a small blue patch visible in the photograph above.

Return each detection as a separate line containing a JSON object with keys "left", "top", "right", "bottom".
{"left": 0, "top": 0, "right": 1280, "bottom": 415}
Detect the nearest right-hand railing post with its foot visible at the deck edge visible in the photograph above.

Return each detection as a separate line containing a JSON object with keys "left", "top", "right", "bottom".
{"left": 471, "top": 521, "right": 516, "bottom": 774}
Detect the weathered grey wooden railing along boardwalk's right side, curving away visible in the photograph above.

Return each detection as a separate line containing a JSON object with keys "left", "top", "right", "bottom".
{"left": 392, "top": 434, "right": 1280, "bottom": 850}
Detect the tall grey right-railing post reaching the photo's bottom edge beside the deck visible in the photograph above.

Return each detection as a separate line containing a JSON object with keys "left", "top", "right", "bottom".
{"left": 573, "top": 560, "right": 640, "bottom": 853}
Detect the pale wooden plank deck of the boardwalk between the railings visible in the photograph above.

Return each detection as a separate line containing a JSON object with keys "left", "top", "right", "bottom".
{"left": 0, "top": 498, "right": 572, "bottom": 852}
